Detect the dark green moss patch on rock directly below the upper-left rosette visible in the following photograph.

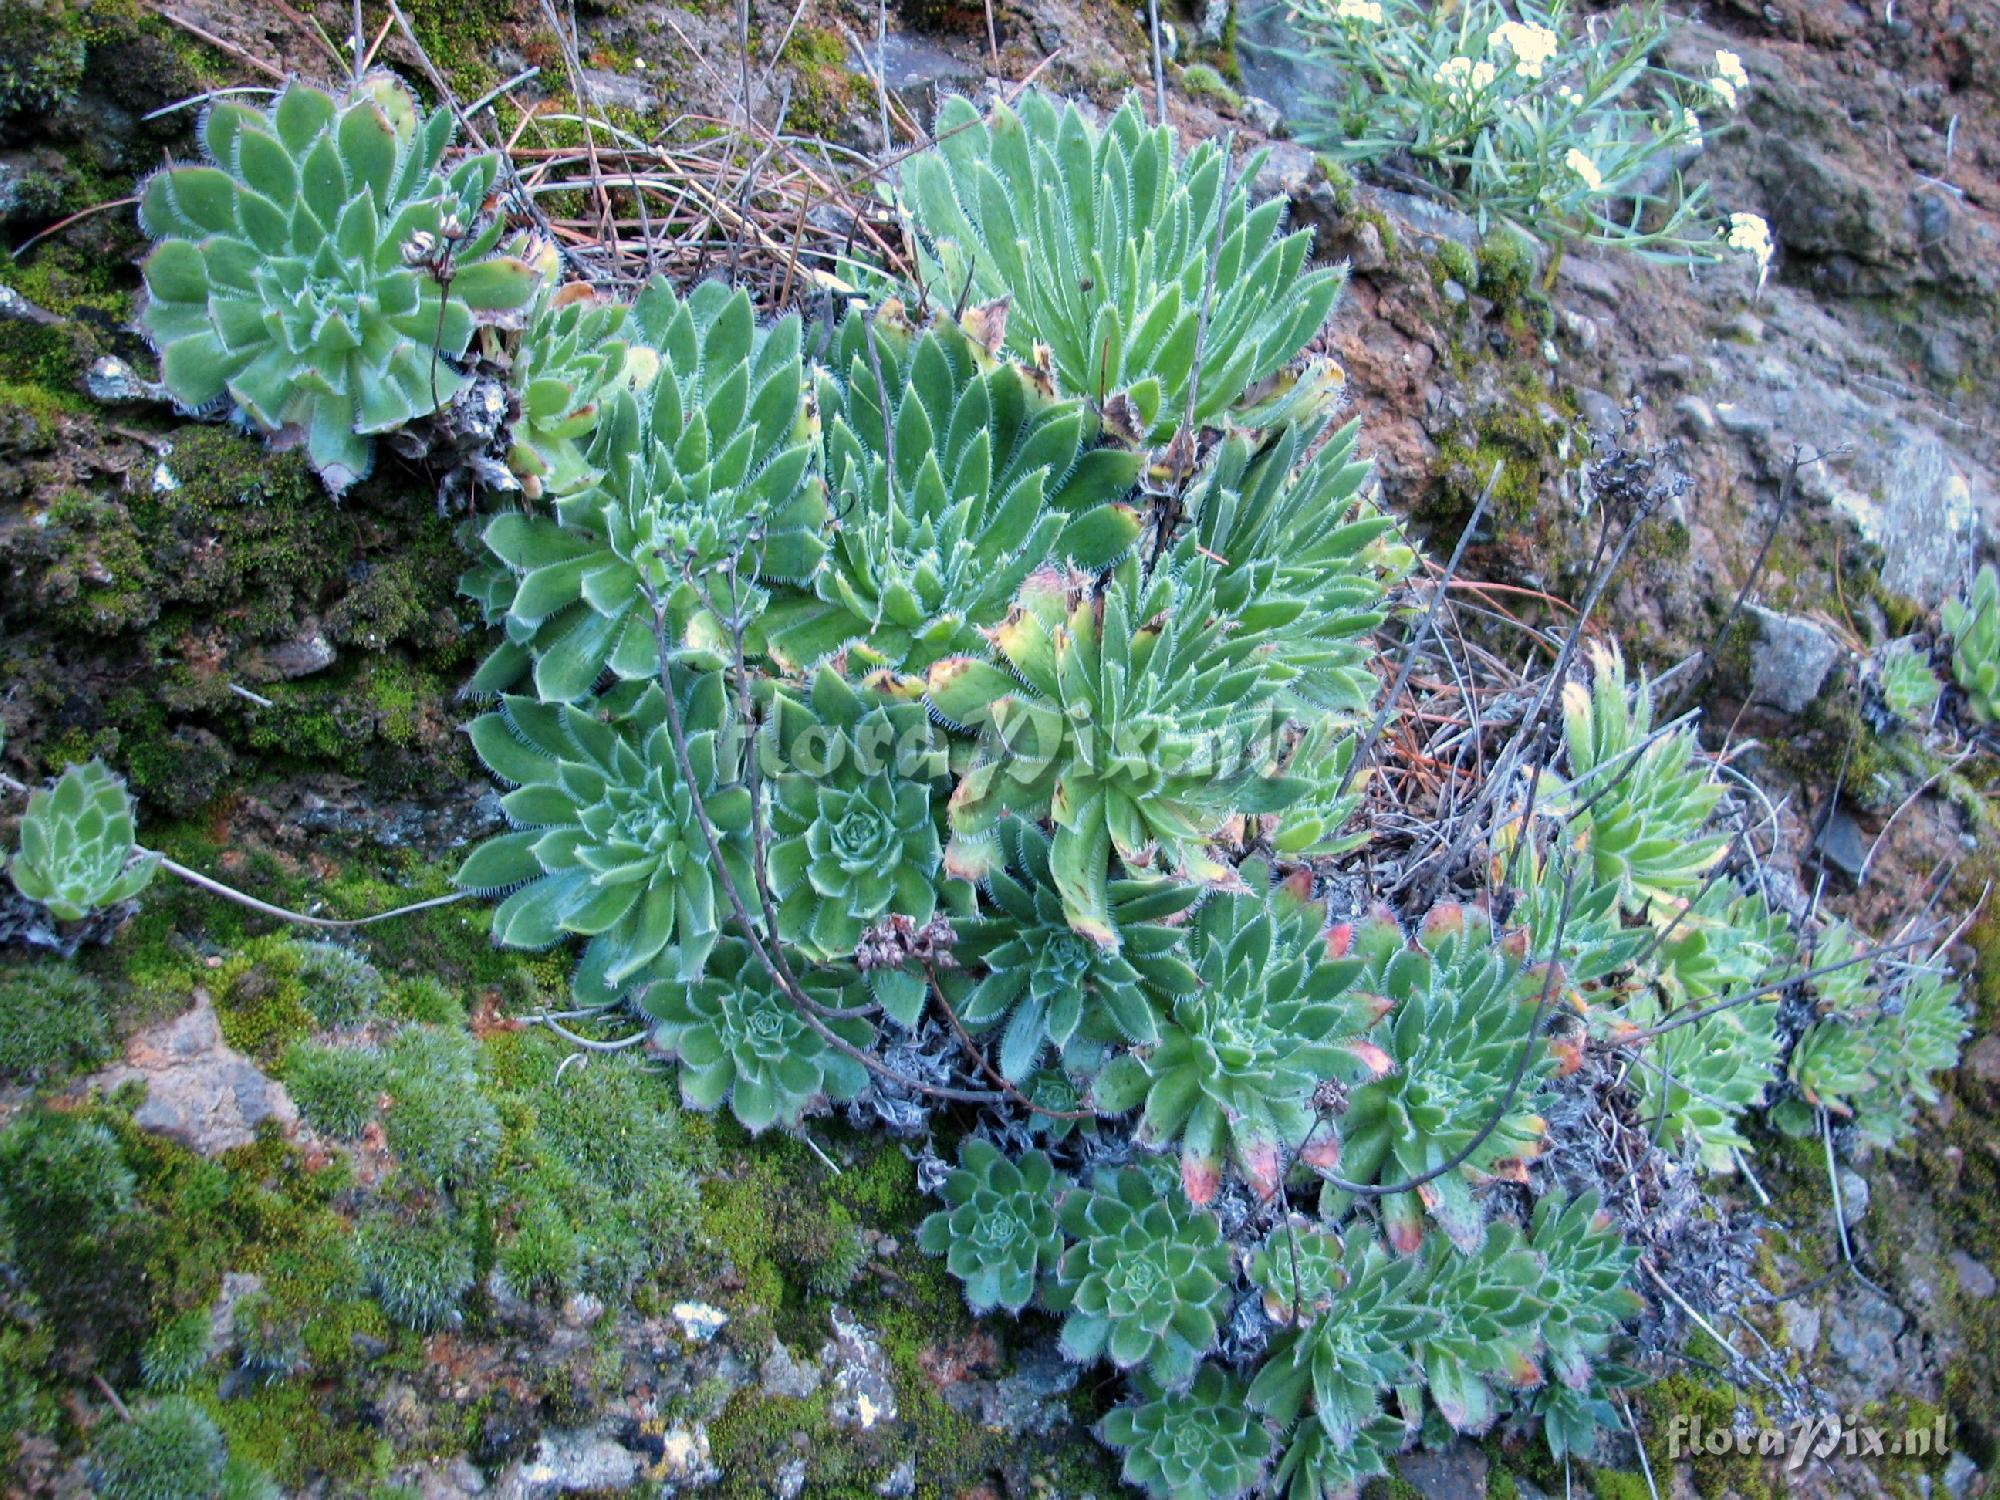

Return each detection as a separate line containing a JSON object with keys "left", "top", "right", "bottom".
{"left": 0, "top": 402, "right": 478, "bottom": 800}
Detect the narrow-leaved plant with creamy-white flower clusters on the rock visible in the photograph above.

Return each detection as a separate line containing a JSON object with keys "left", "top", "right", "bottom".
{"left": 1292, "top": 0, "right": 1770, "bottom": 264}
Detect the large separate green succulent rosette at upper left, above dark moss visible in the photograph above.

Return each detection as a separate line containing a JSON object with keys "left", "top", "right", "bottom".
{"left": 140, "top": 74, "right": 538, "bottom": 494}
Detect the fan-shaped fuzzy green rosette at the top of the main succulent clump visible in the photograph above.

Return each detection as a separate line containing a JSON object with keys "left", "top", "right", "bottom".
{"left": 902, "top": 92, "right": 1344, "bottom": 442}
